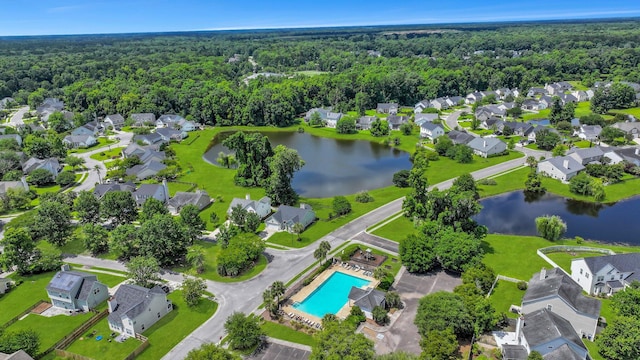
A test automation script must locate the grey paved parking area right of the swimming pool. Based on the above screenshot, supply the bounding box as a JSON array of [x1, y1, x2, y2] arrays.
[[374, 271, 462, 354]]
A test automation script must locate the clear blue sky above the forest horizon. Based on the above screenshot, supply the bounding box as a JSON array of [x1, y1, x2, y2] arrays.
[[0, 0, 640, 36]]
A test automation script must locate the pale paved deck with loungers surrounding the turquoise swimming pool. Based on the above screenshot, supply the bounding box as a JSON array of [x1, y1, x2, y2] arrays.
[[283, 264, 380, 323]]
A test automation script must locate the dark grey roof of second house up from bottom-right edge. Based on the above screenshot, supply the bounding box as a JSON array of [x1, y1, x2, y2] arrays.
[[522, 268, 601, 317]]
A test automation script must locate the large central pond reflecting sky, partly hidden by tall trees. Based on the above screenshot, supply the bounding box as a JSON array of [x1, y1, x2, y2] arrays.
[[204, 132, 411, 198]]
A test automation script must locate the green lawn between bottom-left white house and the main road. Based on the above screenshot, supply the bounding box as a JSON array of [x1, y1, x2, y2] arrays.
[[136, 290, 218, 360]]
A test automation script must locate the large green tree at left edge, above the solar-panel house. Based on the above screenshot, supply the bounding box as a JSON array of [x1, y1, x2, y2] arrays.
[[0, 227, 36, 275]]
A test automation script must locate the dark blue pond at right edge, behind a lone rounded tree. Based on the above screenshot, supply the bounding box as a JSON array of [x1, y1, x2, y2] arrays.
[[475, 191, 640, 245]]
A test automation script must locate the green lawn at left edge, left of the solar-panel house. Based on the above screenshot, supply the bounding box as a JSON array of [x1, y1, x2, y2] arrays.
[[0, 272, 55, 325]]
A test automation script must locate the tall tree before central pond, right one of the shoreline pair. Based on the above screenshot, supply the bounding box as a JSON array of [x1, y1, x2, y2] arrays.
[[265, 145, 304, 205]]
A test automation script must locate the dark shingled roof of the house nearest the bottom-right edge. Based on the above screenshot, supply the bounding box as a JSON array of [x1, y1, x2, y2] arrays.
[[522, 308, 587, 350]]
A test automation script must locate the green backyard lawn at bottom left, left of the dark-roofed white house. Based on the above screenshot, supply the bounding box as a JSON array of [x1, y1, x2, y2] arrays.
[[65, 318, 142, 359]]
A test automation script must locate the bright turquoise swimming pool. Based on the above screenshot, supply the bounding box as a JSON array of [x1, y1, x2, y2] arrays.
[[293, 271, 370, 318]]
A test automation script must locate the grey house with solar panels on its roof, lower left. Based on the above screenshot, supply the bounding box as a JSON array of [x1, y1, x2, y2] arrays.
[[46, 264, 109, 311]]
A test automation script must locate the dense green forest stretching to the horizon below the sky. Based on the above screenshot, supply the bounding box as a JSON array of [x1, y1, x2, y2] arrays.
[[0, 20, 640, 126]]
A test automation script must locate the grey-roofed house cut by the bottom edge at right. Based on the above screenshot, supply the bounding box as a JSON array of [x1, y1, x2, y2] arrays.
[[501, 308, 590, 360]]
